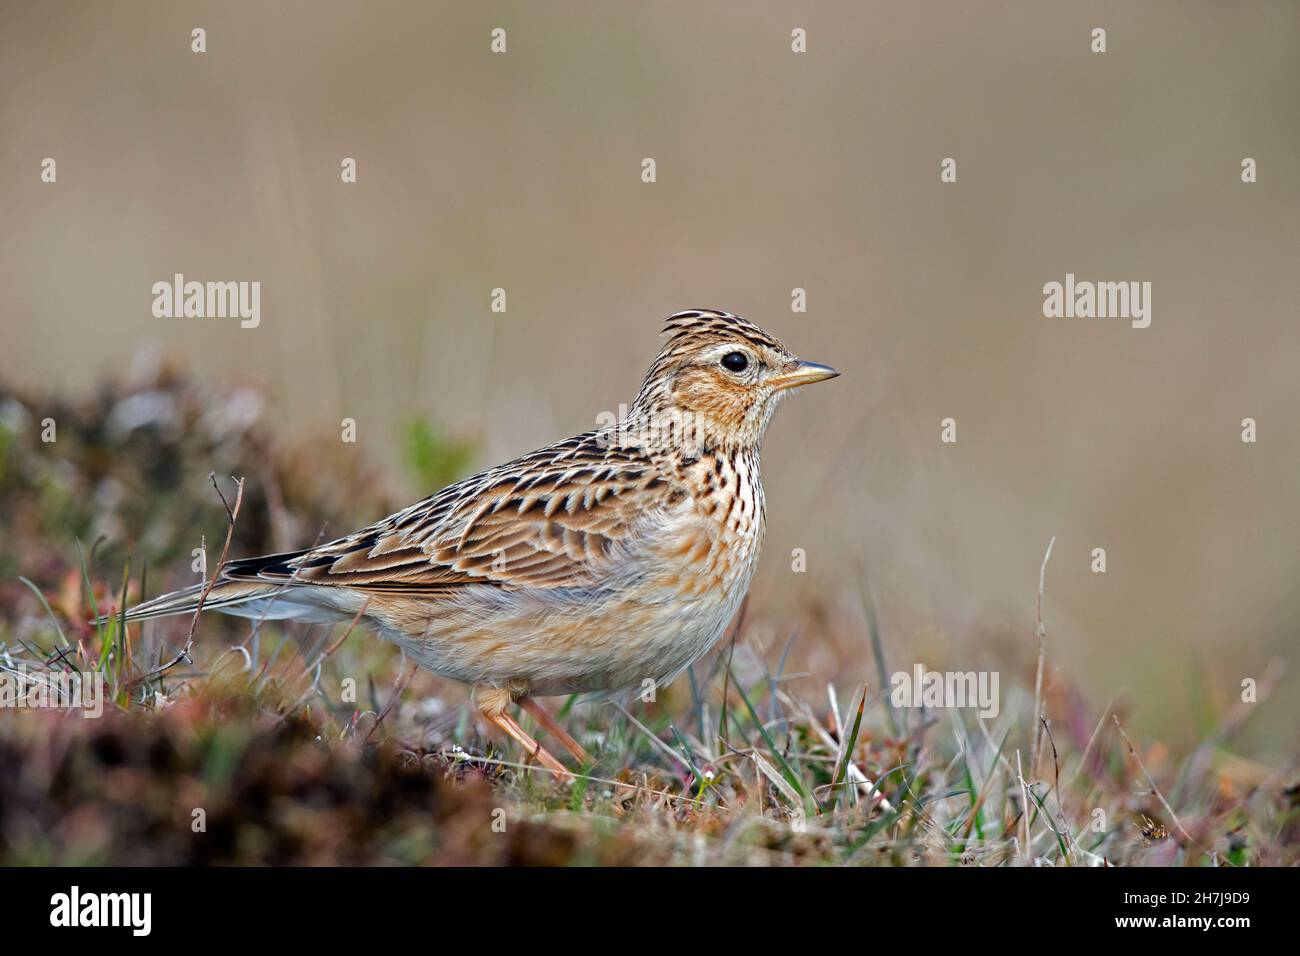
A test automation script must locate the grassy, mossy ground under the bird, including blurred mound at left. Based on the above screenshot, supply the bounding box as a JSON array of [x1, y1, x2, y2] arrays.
[[0, 369, 1300, 866]]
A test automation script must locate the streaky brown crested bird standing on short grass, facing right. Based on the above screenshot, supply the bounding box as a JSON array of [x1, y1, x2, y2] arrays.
[[111, 308, 839, 779]]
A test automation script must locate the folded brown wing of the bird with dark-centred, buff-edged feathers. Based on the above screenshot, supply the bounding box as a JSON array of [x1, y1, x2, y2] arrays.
[[219, 432, 684, 594]]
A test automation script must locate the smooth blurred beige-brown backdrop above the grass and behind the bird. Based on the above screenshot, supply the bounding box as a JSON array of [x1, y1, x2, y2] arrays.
[[0, 0, 1300, 756]]
